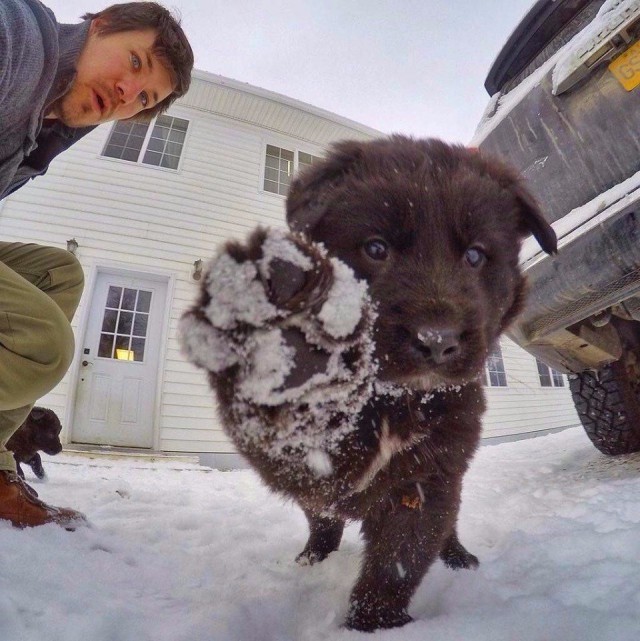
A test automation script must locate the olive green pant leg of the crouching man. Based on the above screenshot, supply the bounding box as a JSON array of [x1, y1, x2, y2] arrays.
[[0, 242, 84, 469]]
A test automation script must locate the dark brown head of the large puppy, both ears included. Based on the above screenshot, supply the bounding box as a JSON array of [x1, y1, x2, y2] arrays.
[[287, 137, 555, 388]]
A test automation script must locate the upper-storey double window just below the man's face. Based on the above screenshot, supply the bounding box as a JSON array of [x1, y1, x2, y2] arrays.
[[102, 115, 189, 169]]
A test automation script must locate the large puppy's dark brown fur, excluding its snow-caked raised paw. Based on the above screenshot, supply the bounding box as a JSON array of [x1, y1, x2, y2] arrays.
[[181, 136, 556, 630]]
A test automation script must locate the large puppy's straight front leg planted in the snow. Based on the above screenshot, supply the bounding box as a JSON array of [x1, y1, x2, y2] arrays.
[[346, 497, 455, 632]]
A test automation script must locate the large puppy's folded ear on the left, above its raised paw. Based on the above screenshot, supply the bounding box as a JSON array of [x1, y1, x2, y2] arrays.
[[287, 140, 363, 233]]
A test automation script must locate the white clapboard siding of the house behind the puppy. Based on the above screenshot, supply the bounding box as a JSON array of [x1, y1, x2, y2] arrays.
[[0, 72, 576, 456]]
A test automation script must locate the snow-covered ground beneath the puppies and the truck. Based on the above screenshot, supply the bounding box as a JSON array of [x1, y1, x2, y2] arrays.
[[0, 429, 640, 641]]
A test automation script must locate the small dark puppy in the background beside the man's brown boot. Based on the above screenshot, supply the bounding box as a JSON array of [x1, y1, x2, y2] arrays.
[[7, 407, 62, 479]]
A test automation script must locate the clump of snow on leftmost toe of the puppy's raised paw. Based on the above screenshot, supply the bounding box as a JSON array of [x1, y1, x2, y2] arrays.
[[178, 314, 238, 372]]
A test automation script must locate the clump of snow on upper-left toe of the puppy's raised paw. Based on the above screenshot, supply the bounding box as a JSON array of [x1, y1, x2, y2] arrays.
[[204, 254, 278, 329]]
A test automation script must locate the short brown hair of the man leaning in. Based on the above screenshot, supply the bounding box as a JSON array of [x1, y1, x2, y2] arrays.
[[82, 2, 193, 121]]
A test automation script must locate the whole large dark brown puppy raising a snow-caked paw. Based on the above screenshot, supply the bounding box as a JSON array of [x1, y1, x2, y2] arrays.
[[181, 136, 556, 631]]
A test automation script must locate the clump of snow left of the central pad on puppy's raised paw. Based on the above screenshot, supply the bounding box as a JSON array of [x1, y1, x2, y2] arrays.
[[238, 328, 295, 405]]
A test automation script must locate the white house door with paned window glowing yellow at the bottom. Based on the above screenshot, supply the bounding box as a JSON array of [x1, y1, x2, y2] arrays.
[[72, 273, 167, 448]]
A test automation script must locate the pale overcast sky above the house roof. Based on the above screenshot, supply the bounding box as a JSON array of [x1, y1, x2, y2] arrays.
[[44, 0, 534, 143]]
